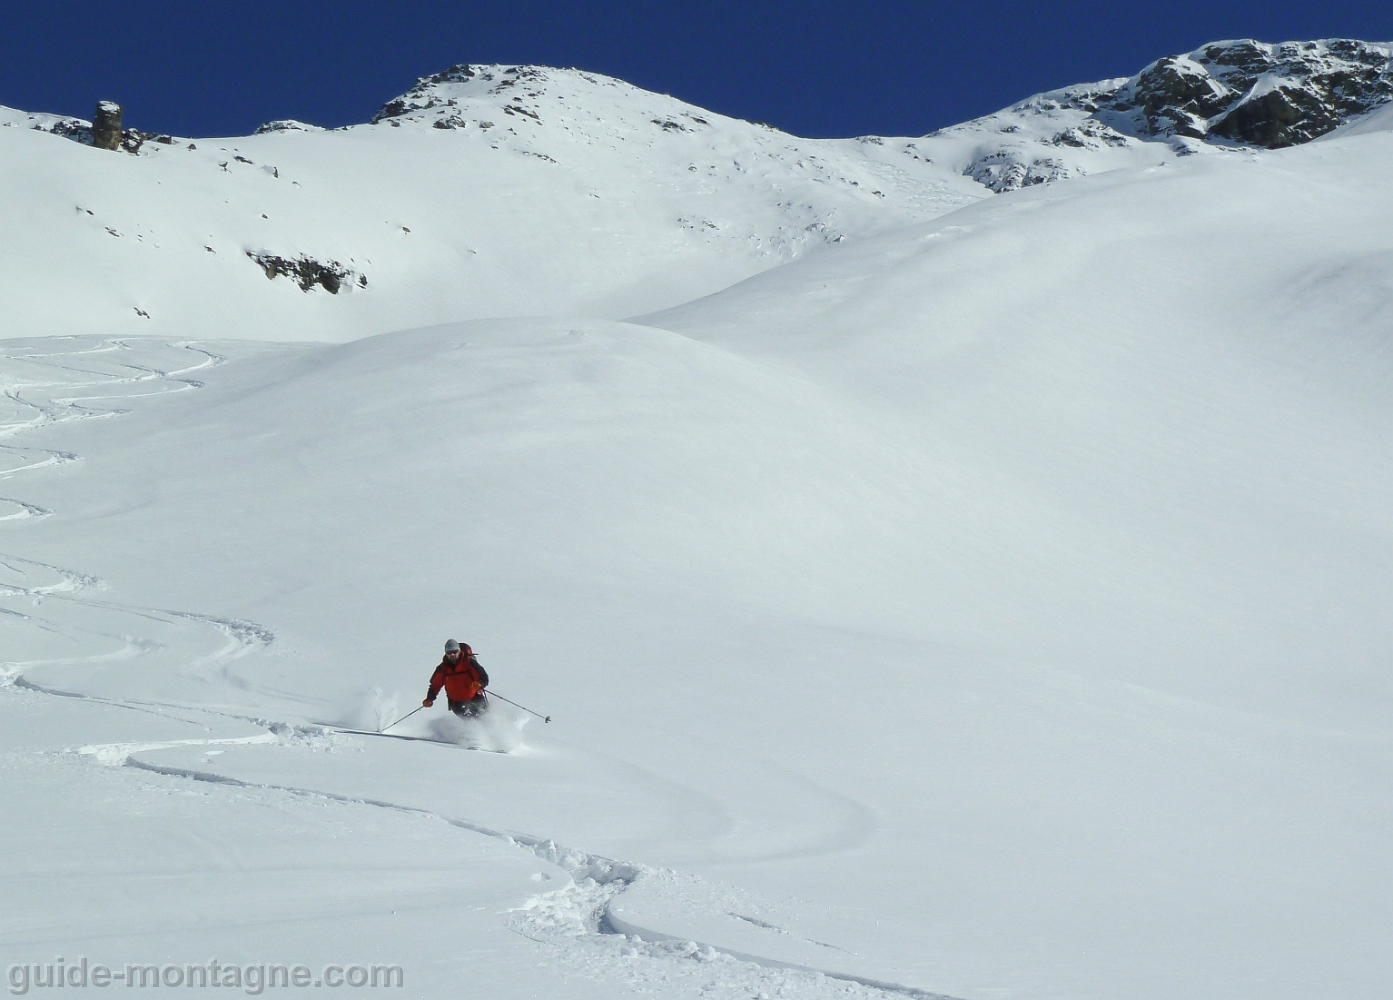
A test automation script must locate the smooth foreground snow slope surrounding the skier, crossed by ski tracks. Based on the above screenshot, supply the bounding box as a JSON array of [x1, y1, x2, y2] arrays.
[[0, 49, 1393, 1000]]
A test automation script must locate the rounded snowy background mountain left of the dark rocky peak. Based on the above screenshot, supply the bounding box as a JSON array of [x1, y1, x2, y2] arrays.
[[0, 67, 986, 341]]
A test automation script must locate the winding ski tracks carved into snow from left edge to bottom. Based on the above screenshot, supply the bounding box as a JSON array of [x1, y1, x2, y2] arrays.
[[0, 337, 954, 1000]]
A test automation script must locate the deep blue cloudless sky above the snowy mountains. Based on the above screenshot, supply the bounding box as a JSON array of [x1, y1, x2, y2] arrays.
[[0, 0, 1393, 136]]
